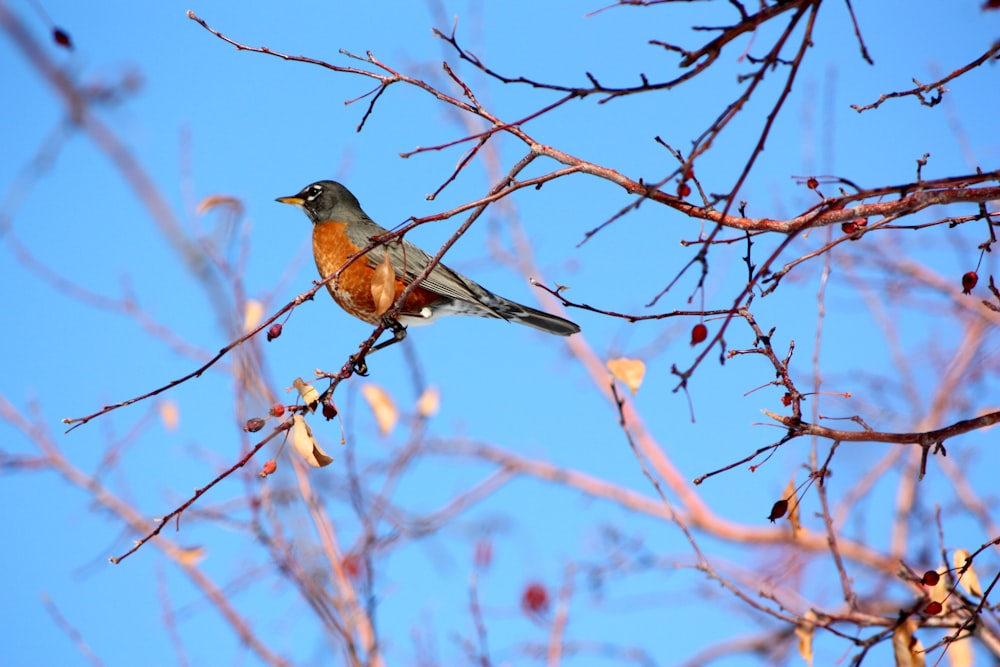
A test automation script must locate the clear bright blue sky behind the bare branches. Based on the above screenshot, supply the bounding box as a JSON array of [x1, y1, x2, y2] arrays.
[[0, 0, 1000, 665]]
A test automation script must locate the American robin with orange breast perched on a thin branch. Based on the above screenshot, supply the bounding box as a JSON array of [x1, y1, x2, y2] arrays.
[[276, 181, 580, 349]]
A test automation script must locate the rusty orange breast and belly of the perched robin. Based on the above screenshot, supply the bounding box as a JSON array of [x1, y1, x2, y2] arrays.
[[313, 222, 441, 324]]
